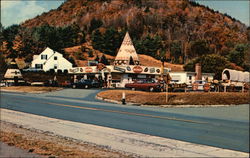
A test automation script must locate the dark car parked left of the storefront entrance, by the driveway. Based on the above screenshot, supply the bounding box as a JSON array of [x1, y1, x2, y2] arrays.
[[72, 79, 100, 89]]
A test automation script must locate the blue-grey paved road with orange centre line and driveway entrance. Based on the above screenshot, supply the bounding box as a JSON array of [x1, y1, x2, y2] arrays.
[[1, 89, 249, 152]]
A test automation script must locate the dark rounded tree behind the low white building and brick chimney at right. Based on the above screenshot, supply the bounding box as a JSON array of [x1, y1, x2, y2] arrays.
[[184, 54, 231, 79]]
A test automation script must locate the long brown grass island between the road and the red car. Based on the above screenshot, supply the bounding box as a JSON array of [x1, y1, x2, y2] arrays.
[[97, 90, 249, 105]]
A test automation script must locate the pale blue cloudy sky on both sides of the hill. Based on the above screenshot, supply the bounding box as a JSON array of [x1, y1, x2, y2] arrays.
[[1, 0, 250, 27]]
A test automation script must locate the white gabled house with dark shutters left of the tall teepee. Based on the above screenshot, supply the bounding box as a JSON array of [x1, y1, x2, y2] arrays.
[[31, 47, 72, 72]]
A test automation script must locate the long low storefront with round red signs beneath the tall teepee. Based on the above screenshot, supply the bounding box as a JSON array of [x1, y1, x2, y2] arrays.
[[69, 65, 170, 87]]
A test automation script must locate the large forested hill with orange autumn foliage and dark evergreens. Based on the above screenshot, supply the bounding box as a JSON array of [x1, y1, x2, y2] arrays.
[[0, 0, 250, 76]]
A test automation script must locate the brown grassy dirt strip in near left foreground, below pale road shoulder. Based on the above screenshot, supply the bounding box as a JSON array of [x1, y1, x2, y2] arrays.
[[0, 121, 129, 157]]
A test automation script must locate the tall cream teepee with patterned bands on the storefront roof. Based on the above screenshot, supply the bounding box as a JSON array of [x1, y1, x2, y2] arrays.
[[114, 32, 140, 65]]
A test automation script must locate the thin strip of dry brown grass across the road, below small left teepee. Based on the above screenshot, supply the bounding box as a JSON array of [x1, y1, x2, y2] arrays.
[[1, 86, 62, 93]]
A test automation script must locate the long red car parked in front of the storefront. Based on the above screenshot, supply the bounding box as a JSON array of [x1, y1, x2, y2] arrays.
[[125, 79, 161, 92]]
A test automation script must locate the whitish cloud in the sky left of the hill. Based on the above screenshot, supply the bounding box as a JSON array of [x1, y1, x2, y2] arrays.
[[1, 0, 48, 27]]
